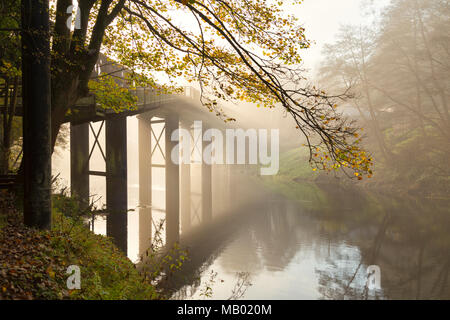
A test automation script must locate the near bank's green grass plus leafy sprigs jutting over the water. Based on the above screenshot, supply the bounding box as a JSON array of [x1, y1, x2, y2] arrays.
[[52, 188, 188, 299]]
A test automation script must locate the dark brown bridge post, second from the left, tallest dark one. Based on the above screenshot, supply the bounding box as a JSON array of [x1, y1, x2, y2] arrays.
[[106, 117, 128, 254]]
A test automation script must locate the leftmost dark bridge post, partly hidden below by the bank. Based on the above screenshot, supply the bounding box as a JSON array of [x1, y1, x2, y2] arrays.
[[70, 123, 89, 206]]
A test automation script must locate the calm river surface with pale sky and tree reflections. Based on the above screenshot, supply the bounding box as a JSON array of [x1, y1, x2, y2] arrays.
[[166, 185, 450, 299]]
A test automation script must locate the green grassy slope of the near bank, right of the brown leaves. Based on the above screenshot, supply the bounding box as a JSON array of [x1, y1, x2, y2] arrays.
[[51, 210, 157, 300]]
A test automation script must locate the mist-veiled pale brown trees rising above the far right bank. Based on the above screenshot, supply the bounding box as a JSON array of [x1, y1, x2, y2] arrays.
[[323, 0, 450, 195]]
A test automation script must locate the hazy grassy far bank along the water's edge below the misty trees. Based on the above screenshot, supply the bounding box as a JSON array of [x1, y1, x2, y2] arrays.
[[265, 129, 450, 200]]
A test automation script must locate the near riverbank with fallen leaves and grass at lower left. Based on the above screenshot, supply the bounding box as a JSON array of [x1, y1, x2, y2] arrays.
[[0, 193, 159, 300]]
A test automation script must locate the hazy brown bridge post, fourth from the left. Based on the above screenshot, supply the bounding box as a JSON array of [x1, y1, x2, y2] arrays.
[[165, 114, 180, 247]]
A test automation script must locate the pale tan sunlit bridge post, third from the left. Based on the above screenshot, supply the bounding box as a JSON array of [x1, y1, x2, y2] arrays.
[[138, 118, 152, 256]]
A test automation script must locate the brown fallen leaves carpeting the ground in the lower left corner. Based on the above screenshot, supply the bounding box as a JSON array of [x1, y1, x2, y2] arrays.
[[0, 195, 69, 300]]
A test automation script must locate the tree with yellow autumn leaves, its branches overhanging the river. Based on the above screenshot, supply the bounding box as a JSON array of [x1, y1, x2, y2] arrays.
[[44, 0, 371, 178]]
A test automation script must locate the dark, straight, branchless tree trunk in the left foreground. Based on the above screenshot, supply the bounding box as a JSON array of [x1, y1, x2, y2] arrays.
[[21, 0, 51, 229]]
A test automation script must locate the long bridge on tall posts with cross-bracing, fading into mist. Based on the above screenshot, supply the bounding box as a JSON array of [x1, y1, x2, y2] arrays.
[[67, 53, 255, 254]]
